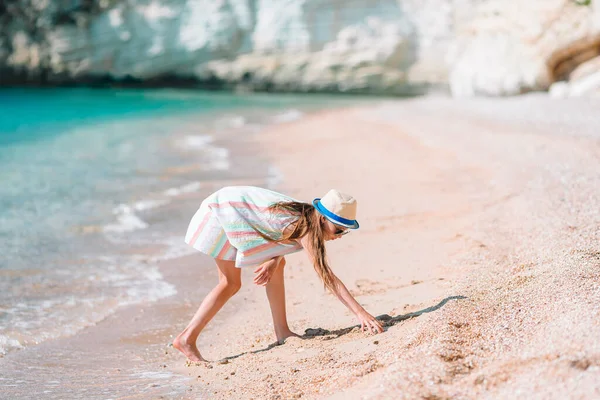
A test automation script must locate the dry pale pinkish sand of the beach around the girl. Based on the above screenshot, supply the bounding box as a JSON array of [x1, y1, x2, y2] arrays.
[[169, 95, 600, 399]]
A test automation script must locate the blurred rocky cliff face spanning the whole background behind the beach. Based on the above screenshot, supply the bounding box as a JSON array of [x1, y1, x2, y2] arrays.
[[0, 0, 600, 96]]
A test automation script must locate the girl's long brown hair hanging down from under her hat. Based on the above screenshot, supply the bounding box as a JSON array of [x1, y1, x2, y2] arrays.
[[259, 201, 335, 292]]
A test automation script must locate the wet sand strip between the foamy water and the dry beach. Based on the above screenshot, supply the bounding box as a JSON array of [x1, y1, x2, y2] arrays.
[[0, 98, 370, 398]]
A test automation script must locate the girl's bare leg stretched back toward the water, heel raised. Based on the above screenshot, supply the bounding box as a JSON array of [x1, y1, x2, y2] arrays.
[[173, 259, 242, 361]]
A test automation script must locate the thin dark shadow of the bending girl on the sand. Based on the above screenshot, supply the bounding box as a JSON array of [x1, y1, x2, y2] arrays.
[[209, 296, 466, 364]]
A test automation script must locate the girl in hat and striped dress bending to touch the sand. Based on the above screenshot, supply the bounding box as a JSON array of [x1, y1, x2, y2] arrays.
[[173, 186, 383, 361]]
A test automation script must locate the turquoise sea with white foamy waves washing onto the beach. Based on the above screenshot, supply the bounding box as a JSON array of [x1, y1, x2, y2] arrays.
[[0, 89, 350, 354]]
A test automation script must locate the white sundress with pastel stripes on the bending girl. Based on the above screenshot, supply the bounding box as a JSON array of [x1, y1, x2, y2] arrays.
[[185, 186, 302, 268]]
